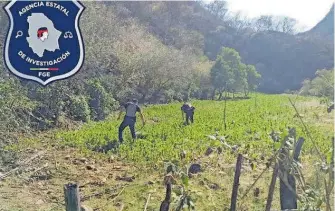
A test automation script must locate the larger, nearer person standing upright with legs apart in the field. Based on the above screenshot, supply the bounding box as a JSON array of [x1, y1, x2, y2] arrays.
[[118, 99, 145, 143]]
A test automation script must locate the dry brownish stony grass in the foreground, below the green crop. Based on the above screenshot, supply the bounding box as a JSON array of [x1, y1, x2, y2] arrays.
[[0, 138, 278, 211]]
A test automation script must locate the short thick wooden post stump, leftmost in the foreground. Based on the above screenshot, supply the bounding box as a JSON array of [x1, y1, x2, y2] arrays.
[[64, 183, 81, 211]]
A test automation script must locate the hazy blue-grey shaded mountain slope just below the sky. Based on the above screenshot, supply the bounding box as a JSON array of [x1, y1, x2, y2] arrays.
[[117, 2, 334, 93]]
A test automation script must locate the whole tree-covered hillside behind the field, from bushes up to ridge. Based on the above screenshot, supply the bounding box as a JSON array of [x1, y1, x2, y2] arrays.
[[0, 1, 333, 135]]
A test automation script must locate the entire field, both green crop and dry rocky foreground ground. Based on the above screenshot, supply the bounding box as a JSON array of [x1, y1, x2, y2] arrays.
[[0, 94, 333, 211]]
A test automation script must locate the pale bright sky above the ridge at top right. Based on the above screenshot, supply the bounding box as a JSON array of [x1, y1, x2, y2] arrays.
[[208, 0, 334, 30]]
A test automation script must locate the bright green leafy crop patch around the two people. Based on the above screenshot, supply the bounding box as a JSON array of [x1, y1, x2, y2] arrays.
[[57, 95, 332, 165]]
